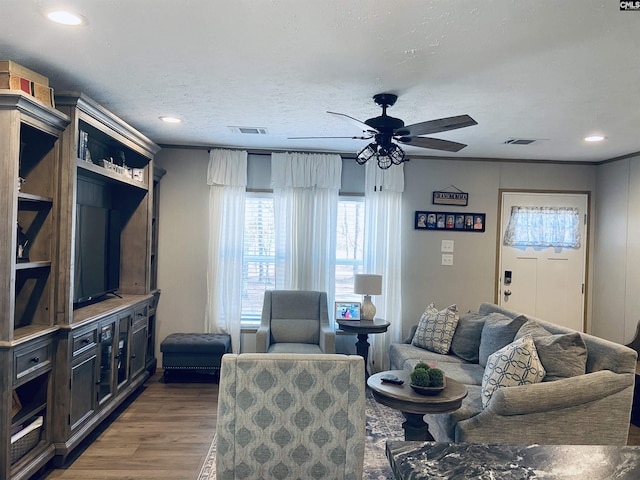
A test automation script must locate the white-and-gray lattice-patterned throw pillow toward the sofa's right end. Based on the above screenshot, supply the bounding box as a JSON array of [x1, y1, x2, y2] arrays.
[[482, 335, 546, 408]]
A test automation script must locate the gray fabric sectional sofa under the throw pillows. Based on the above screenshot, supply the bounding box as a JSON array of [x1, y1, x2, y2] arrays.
[[389, 303, 637, 445]]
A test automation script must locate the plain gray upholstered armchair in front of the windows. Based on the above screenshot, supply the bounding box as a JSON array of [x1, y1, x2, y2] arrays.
[[256, 290, 336, 353]]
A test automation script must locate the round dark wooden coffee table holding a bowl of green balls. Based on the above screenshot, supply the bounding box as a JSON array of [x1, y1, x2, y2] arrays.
[[367, 370, 467, 441]]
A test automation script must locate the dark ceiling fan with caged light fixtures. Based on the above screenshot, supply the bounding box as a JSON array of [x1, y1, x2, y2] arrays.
[[291, 93, 478, 169]]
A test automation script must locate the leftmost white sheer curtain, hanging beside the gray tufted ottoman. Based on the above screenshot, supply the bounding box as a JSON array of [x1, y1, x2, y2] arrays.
[[204, 149, 247, 353]]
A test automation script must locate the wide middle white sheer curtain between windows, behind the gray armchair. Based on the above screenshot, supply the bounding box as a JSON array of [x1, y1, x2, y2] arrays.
[[271, 153, 342, 322]]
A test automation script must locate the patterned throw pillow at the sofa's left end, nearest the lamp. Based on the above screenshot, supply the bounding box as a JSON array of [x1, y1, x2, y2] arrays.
[[411, 303, 459, 355]]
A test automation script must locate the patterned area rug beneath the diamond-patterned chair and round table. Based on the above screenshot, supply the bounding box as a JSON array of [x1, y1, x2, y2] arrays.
[[198, 390, 404, 480]]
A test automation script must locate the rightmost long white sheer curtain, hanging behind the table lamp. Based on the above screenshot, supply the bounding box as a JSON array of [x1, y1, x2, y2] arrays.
[[364, 162, 404, 372]]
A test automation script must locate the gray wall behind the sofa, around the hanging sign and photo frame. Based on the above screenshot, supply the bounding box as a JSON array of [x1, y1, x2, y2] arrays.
[[402, 159, 595, 335]]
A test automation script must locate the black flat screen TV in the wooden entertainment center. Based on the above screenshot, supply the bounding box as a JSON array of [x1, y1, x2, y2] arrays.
[[73, 204, 120, 305]]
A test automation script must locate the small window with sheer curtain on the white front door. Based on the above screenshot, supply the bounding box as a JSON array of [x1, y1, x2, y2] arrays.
[[504, 206, 580, 248]]
